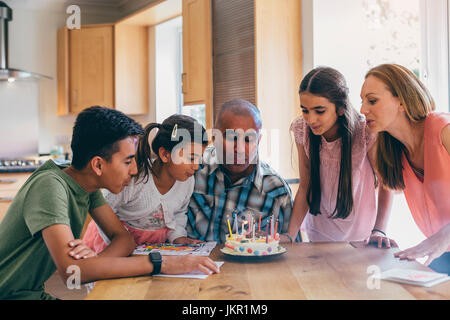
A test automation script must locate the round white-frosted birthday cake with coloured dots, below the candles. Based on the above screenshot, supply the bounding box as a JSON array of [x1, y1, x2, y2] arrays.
[[224, 233, 284, 256]]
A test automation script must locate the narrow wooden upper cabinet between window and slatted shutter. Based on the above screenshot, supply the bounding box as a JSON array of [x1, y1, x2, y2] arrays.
[[182, 0, 213, 128]]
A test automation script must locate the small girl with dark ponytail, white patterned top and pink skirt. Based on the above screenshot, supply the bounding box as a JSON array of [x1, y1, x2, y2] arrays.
[[83, 115, 208, 253]]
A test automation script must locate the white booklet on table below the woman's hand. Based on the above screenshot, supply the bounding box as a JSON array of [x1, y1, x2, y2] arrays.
[[380, 269, 450, 287]]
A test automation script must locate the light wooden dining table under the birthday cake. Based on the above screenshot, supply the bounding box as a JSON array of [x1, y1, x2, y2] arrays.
[[86, 242, 450, 300]]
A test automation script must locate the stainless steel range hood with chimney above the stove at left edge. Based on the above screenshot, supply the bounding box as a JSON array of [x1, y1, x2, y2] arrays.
[[0, 1, 51, 82]]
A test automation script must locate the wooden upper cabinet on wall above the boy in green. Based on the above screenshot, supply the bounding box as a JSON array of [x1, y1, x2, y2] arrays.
[[58, 24, 149, 115]]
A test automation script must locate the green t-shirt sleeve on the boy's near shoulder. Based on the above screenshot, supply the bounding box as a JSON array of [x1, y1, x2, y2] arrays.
[[23, 175, 70, 236]]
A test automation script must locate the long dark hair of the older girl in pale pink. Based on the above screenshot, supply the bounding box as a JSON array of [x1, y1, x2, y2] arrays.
[[299, 67, 361, 219]]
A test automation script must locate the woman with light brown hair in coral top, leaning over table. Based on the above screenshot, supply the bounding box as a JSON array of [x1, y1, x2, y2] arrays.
[[361, 64, 450, 273]]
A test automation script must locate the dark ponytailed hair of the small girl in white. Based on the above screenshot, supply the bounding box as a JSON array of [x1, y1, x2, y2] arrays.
[[136, 114, 208, 183]]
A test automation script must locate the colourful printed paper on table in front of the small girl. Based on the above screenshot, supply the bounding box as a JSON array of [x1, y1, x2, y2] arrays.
[[133, 241, 217, 257]]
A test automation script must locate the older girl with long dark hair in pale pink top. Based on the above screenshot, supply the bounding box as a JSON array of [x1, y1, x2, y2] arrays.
[[288, 67, 396, 247]]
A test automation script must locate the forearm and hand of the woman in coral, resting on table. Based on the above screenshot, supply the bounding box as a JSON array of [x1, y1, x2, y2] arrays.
[[394, 224, 450, 266]]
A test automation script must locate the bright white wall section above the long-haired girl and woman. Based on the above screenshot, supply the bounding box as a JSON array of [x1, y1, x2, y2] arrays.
[[312, 0, 420, 110]]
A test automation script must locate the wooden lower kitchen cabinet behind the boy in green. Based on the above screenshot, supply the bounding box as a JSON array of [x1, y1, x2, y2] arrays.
[[0, 172, 31, 222]]
